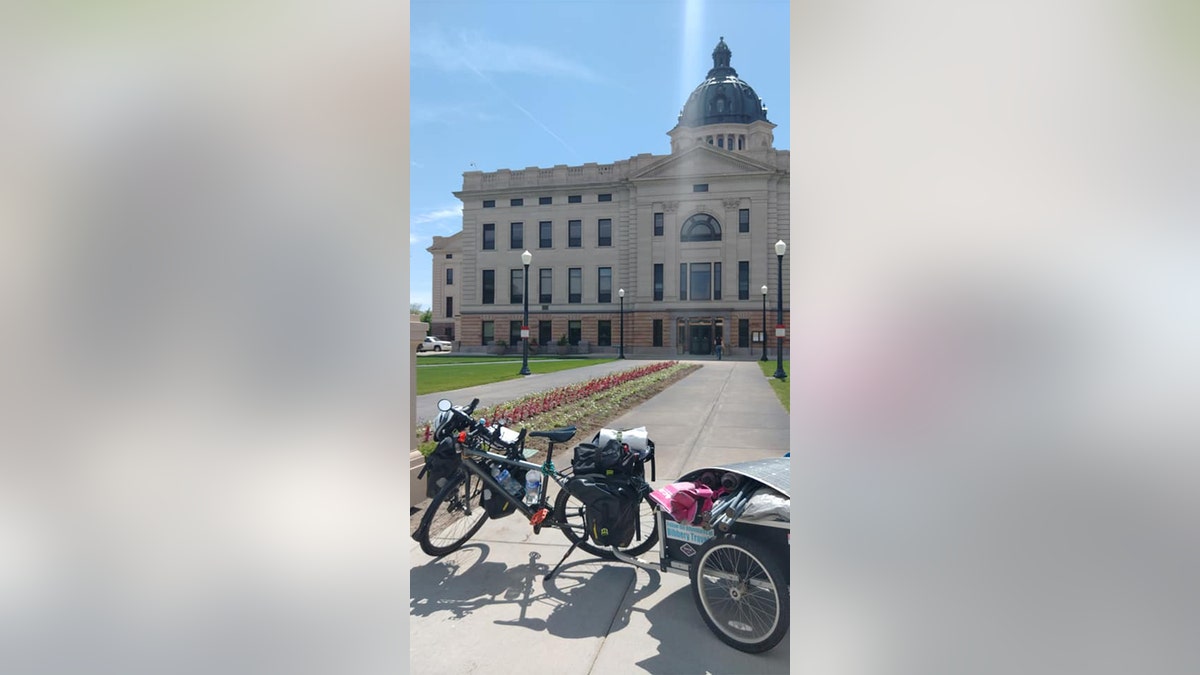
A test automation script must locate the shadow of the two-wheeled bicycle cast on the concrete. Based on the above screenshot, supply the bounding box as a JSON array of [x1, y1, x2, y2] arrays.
[[409, 543, 660, 639]]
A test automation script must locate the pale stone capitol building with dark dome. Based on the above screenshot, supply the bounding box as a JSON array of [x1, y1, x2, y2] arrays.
[[427, 38, 792, 359]]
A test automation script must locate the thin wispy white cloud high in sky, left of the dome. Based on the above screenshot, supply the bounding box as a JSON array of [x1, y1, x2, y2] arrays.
[[412, 30, 601, 82]]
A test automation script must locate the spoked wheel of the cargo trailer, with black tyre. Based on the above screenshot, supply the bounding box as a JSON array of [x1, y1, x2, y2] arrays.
[[690, 534, 790, 653]]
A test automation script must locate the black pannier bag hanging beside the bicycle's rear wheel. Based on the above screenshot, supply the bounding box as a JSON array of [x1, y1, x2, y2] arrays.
[[566, 474, 650, 548]]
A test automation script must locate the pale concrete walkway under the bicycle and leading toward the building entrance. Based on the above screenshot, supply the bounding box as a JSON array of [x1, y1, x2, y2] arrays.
[[409, 360, 790, 675]]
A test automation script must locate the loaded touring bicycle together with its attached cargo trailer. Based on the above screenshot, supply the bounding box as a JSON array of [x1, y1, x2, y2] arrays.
[[413, 399, 790, 652]]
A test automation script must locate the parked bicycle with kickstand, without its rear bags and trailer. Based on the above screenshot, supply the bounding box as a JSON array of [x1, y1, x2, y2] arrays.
[[413, 399, 659, 579]]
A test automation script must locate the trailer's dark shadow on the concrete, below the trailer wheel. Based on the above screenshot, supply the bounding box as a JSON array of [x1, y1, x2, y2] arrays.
[[637, 586, 791, 675]]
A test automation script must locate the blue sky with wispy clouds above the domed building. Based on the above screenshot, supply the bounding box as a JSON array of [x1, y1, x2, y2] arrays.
[[409, 0, 791, 306]]
